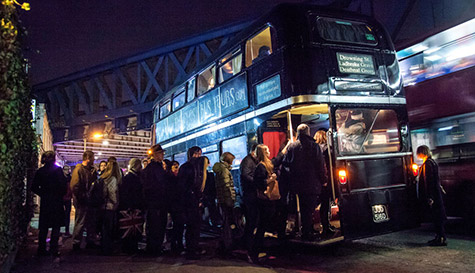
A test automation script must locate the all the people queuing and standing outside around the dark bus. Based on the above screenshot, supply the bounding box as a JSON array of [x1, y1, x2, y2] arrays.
[[32, 126, 447, 263]]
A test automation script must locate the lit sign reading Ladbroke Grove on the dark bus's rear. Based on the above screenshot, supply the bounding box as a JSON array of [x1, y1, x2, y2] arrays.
[[336, 52, 376, 75]]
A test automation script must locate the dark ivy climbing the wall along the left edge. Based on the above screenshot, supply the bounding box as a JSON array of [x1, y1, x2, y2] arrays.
[[0, 0, 37, 265]]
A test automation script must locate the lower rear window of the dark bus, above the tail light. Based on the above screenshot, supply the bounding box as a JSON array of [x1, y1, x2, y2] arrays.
[[335, 108, 401, 155]]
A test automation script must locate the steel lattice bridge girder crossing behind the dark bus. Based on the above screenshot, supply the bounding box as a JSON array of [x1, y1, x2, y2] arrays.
[[34, 22, 249, 141]]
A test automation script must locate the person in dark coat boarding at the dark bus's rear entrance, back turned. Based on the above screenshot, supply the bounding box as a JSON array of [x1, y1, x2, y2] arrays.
[[283, 124, 325, 240]]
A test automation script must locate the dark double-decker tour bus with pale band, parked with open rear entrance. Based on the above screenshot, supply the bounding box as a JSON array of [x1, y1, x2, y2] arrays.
[[153, 4, 418, 243]]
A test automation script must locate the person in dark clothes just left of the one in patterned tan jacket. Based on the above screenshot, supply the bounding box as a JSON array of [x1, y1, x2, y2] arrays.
[[178, 154, 209, 260]]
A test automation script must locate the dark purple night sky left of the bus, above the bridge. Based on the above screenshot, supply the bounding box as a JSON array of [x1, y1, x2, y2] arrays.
[[21, 0, 302, 84]]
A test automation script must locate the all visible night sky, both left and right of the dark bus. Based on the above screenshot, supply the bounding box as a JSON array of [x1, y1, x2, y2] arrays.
[[20, 0, 475, 85]]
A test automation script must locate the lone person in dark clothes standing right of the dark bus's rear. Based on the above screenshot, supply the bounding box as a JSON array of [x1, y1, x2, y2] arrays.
[[416, 145, 447, 246]]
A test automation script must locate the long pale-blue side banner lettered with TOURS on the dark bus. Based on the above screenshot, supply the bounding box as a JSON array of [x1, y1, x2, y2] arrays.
[[155, 74, 249, 143]]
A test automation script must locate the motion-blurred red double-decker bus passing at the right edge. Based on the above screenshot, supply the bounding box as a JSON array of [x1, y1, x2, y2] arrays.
[[397, 19, 475, 223]]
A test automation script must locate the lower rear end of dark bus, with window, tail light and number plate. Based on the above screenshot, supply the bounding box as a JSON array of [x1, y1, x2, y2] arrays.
[[331, 106, 417, 239]]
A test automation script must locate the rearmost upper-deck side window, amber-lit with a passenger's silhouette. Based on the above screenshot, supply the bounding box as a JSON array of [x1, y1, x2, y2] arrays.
[[246, 27, 272, 67]]
